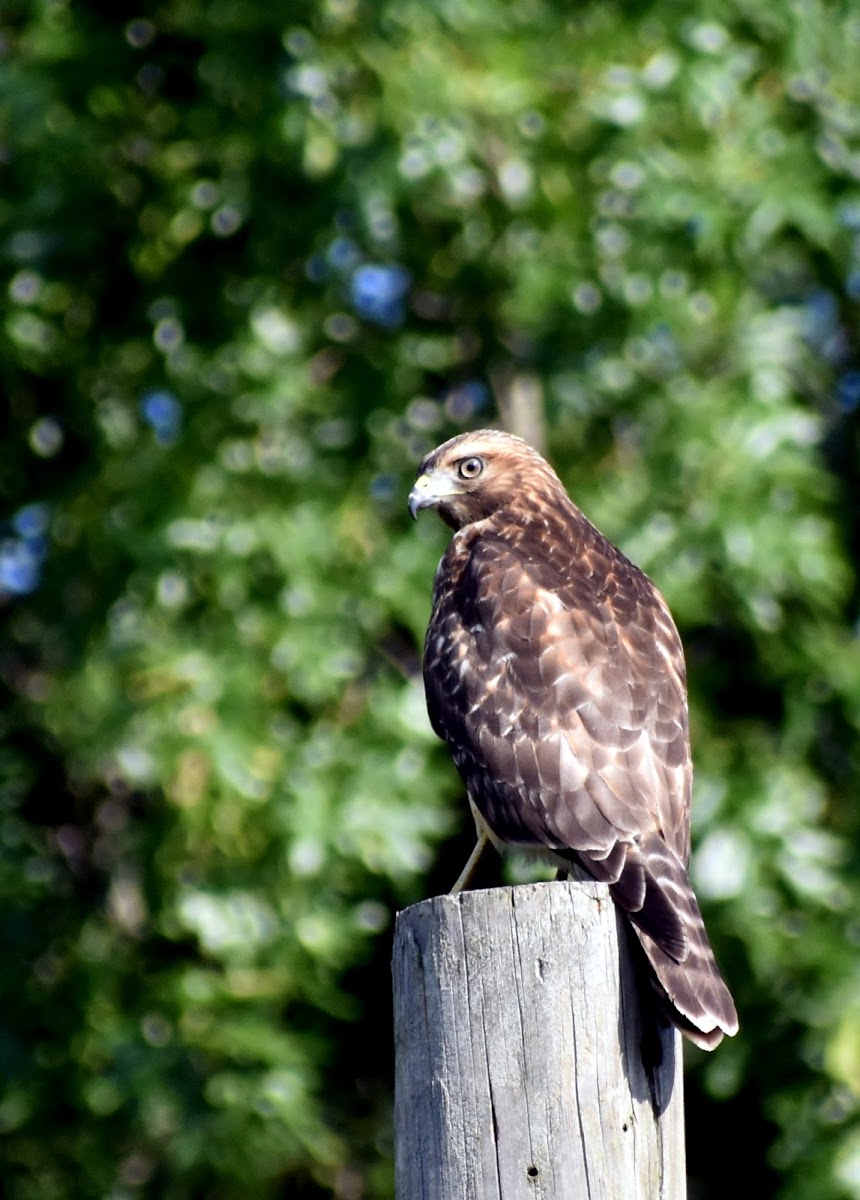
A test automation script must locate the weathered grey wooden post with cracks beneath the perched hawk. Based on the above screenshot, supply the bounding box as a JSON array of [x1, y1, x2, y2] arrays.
[[393, 882, 686, 1200]]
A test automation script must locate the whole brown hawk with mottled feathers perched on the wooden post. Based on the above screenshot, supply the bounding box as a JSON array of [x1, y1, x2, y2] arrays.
[[409, 430, 738, 1050]]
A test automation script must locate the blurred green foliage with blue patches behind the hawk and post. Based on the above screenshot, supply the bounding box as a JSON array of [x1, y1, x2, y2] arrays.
[[0, 0, 860, 1200]]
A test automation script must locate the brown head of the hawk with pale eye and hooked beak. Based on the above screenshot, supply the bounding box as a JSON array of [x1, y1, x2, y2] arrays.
[[409, 430, 567, 529]]
